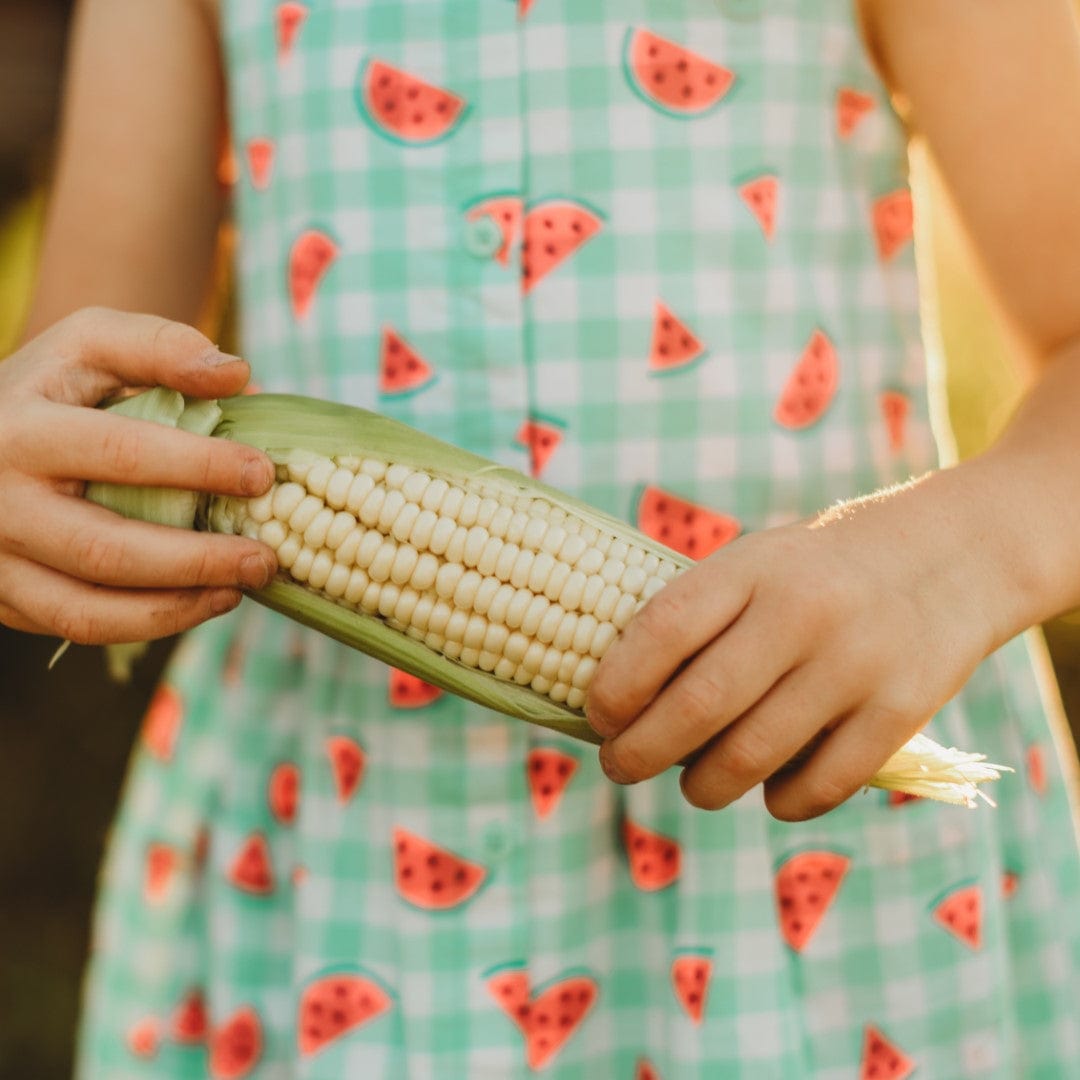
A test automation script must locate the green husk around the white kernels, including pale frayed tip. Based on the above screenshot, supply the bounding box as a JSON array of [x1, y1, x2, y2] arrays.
[[86, 388, 1011, 806]]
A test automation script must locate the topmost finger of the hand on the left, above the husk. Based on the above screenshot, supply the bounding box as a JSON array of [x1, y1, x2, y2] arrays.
[[40, 308, 251, 405]]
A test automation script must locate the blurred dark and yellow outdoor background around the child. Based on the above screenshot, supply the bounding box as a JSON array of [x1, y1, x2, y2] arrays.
[[0, 0, 1080, 1080]]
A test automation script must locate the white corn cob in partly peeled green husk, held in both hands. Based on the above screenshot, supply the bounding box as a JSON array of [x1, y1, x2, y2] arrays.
[[87, 389, 998, 805]]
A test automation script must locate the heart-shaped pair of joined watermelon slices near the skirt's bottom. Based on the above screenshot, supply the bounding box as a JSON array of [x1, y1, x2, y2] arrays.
[[487, 970, 598, 1069]]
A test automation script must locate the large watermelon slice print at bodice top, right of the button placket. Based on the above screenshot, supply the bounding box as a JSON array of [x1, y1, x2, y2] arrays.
[[623, 28, 734, 117]]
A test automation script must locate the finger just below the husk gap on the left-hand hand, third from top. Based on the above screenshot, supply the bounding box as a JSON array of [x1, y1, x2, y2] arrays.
[[8, 494, 276, 589]]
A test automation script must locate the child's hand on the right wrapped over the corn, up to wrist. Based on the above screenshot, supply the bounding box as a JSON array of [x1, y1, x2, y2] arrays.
[[588, 470, 1021, 821]]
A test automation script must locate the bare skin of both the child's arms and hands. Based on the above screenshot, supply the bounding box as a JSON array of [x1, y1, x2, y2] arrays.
[[0, 0, 1080, 820]]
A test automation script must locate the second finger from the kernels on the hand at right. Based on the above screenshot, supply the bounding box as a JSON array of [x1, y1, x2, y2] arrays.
[[600, 618, 797, 783]]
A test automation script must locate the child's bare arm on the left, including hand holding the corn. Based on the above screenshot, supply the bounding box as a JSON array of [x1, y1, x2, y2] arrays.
[[0, 0, 273, 642]]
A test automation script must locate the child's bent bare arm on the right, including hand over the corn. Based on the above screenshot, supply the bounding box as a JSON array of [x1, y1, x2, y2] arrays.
[[590, 0, 1080, 820]]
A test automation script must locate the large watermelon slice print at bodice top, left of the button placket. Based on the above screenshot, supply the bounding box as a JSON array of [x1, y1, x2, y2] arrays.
[[357, 59, 468, 146]]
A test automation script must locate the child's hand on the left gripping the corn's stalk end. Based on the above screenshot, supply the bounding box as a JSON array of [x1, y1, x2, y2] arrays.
[[0, 308, 276, 644]]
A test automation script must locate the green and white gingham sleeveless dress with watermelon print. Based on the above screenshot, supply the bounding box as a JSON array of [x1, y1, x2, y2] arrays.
[[79, 0, 1080, 1080]]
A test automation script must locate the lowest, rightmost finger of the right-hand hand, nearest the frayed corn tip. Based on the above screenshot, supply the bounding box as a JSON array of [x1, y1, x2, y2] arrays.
[[765, 706, 924, 821]]
